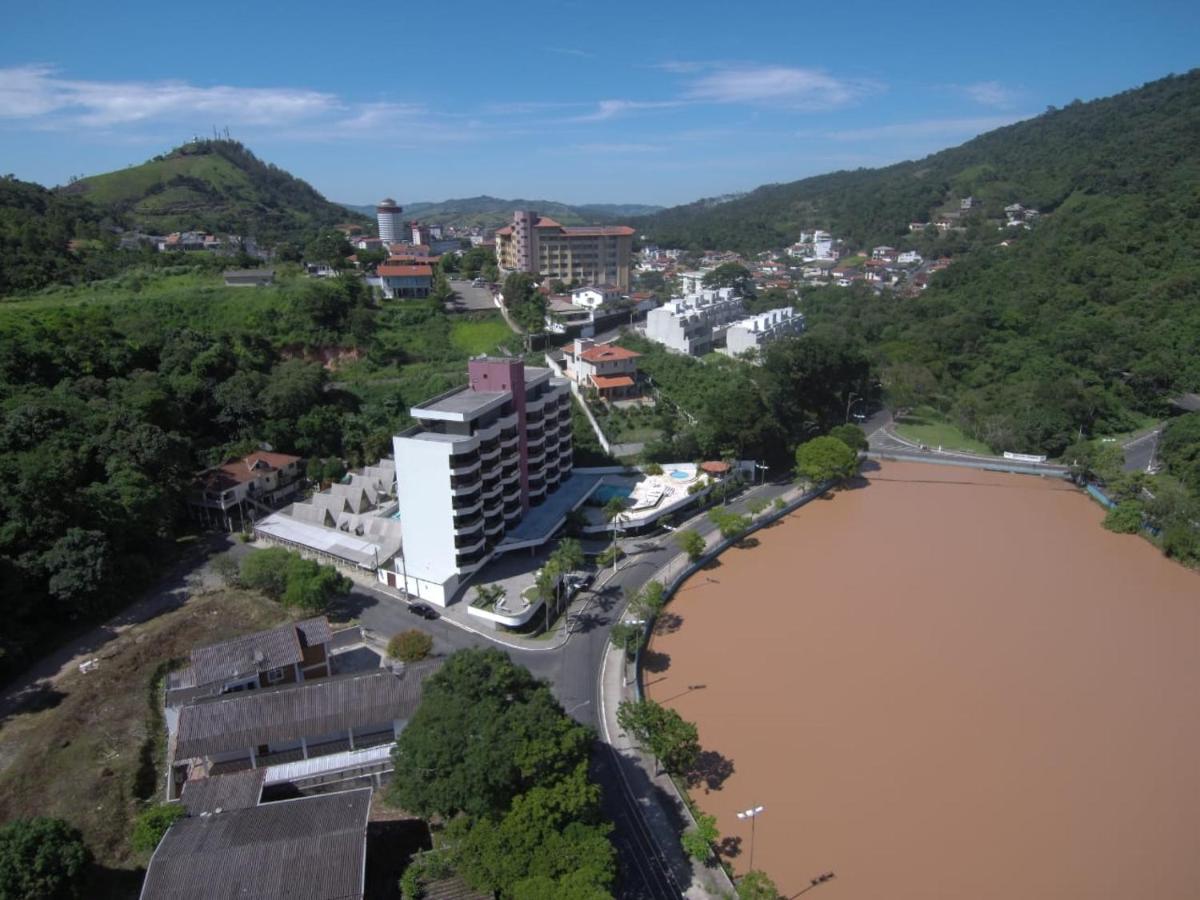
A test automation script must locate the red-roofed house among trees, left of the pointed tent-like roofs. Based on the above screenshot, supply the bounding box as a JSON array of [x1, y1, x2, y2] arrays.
[[187, 450, 304, 528]]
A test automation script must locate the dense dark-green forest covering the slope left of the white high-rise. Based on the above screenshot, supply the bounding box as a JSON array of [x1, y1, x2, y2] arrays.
[[0, 268, 512, 679]]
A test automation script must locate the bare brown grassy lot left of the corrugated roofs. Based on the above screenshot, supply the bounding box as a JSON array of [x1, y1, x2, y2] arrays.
[[0, 590, 289, 875]]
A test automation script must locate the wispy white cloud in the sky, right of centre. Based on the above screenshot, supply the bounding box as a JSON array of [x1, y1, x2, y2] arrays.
[[673, 64, 882, 110]]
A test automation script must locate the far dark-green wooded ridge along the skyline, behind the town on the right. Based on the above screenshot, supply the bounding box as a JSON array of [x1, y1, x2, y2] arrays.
[[648, 70, 1200, 252]]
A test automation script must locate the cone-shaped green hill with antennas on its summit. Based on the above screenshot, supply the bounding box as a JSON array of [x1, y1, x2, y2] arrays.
[[61, 140, 360, 242]]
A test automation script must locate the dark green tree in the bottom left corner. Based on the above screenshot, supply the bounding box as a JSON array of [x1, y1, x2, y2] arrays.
[[0, 818, 91, 900]]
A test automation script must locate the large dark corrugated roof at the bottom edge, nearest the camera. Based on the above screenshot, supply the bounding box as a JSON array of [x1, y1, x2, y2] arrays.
[[142, 787, 371, 900]]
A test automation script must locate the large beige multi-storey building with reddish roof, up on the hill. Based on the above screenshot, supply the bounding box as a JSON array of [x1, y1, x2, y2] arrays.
[[496, 210, 634, 290]]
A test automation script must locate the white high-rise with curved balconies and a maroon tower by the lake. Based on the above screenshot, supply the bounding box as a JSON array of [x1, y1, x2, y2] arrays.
[[393, 358, 572, 606]]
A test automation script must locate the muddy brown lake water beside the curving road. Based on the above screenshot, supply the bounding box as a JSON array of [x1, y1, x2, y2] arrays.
[[646, 463, 1200, 900]]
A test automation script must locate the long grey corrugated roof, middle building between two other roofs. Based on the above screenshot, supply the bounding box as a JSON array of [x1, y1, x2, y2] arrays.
[[175, 660, 442, 760]]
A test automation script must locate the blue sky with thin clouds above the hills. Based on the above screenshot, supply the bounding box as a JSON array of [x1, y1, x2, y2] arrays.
[[0, 0, 1200, 204]]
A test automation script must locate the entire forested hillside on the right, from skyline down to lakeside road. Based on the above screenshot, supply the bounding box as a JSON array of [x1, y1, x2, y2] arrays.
[[647, 71, 1200, 455]]
